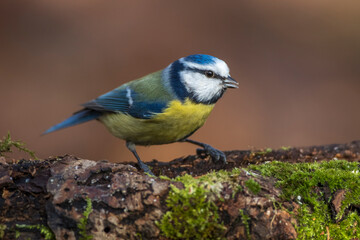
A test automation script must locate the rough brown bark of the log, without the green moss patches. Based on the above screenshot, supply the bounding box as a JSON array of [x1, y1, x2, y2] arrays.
[[0, 141, 360, 239]]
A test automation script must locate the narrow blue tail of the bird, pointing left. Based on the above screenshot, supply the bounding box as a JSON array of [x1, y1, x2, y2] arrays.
[[43, 109, 101, 134]]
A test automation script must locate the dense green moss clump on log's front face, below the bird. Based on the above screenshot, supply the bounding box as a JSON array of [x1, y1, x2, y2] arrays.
[[158, 181, 224, 239]]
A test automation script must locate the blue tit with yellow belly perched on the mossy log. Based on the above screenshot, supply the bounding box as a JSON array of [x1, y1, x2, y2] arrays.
[[44, 54, 238, 175]]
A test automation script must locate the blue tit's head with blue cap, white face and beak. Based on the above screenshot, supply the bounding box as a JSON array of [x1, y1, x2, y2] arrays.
[[164, 54, 238, 104]]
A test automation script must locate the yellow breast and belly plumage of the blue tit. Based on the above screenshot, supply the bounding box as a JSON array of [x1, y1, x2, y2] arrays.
[[100, 99, 214, 145]]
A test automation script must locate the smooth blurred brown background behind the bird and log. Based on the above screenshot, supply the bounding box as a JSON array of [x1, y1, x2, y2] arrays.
[[0, 0, 360, 162]]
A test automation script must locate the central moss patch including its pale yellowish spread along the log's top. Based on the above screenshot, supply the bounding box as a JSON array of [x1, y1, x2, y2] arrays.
[[157, 168, 248, 239]]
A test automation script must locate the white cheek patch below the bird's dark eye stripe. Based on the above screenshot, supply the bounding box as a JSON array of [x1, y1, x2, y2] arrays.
[[181, 71, 223, 102]]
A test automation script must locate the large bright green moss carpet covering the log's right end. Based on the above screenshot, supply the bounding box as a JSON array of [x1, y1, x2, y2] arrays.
[[249, 160, 360, 239]]
